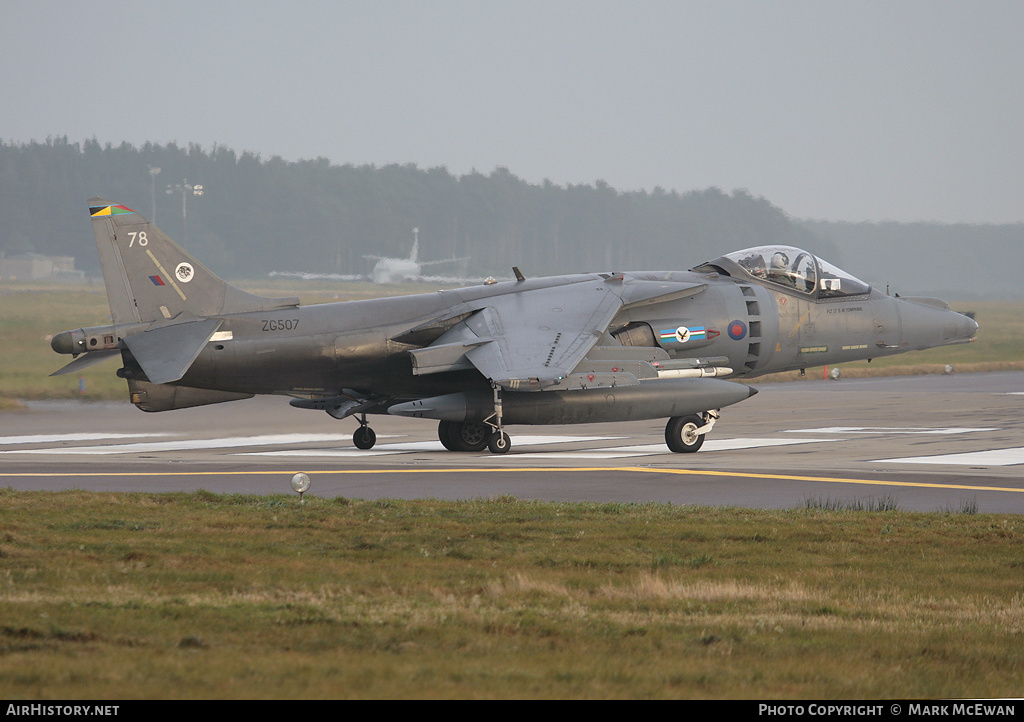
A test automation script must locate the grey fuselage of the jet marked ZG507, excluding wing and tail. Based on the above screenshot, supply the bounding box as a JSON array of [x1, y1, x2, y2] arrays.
[[127, 266, 977, 399]]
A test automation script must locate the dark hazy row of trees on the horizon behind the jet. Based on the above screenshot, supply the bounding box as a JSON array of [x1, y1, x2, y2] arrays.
[[0, 137, 827, 278]]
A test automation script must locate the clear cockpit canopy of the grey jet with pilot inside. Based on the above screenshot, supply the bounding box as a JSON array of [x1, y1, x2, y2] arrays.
[[698, 246, 871, 298]]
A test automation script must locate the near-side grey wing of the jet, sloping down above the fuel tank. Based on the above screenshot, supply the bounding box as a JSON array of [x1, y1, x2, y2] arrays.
[[410, 277, 705, 391]]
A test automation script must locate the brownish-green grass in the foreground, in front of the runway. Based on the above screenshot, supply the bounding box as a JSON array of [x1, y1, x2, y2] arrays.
[[0, 490, 1024, 699]]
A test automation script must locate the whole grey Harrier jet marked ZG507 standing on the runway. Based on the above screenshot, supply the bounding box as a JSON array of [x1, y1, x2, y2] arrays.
[[51, 198, 978, 453]]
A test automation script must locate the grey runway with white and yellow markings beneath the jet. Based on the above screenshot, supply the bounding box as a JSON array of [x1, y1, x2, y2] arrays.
[[0, 372, 1024, 513]]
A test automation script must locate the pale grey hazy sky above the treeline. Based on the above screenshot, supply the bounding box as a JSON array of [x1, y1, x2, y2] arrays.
[[0, 0, 1024, 222]]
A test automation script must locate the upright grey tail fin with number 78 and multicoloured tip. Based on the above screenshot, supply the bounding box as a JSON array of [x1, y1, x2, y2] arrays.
[[89, 198, 299, 325]]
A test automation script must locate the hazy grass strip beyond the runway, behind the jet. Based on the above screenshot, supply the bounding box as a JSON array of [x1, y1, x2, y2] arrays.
[[0, 280, 1024, 409]]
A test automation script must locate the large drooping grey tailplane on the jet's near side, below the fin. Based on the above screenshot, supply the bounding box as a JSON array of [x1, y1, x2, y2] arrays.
[[124, 318, 224, 384]]
